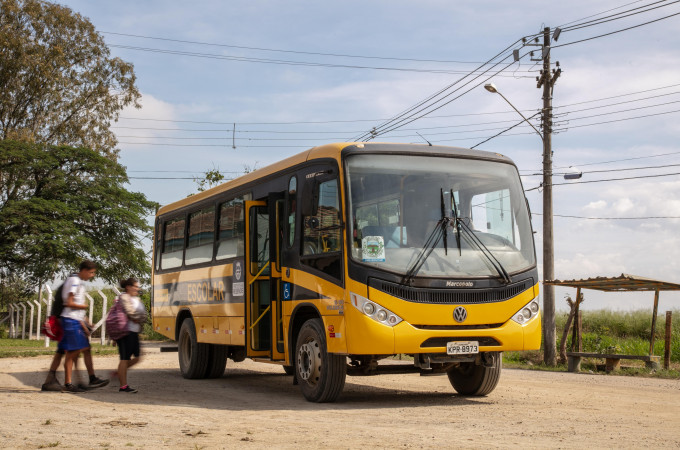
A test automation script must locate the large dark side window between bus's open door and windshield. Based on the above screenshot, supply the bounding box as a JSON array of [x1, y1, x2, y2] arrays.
[[302, 179, 342, 279]]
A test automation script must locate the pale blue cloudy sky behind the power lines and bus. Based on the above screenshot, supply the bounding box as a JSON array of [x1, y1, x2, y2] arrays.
[[58, 0, 680, 311]]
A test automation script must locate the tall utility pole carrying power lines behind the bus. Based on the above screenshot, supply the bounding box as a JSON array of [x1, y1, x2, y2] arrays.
[[536, 27, 561, 366]]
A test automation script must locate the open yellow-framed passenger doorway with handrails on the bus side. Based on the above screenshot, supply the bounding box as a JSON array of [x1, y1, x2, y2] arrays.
[[245, 201, 276, 357]]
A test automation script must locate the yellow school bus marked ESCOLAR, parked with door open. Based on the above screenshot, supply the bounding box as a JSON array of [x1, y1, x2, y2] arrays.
[[152, 143, 541, 402]]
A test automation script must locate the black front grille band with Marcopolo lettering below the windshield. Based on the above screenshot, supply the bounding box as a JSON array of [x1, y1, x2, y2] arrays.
[[369, 278, 533, 305]]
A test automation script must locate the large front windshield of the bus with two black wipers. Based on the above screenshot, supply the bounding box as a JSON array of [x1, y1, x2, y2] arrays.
[[346, 154, 535, 278]]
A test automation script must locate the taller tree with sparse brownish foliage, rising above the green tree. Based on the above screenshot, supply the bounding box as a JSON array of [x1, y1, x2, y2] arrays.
[[0, 0, 141, 158]]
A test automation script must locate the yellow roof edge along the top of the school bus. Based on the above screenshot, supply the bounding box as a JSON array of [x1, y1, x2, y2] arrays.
[[156, 142, 512, 216]]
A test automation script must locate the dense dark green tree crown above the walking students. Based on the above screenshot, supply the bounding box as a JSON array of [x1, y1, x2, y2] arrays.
[[0, 140, 157, 300]]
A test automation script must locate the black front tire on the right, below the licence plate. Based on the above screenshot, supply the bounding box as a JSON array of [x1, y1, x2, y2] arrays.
[[447, 352, 503, 396]]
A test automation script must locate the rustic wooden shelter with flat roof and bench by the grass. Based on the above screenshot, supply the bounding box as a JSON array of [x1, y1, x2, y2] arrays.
[[544, 274, 680, 371]]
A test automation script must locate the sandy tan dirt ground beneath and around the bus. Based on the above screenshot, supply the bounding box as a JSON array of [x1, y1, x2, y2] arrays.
[[0, 342, 680, 449]]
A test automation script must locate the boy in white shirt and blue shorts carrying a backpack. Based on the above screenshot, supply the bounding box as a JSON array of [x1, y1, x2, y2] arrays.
[[42, 260, 109, 392]]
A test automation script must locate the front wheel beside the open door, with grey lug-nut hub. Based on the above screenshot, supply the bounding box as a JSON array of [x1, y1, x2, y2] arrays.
[[295, 319, 347, 403]]
